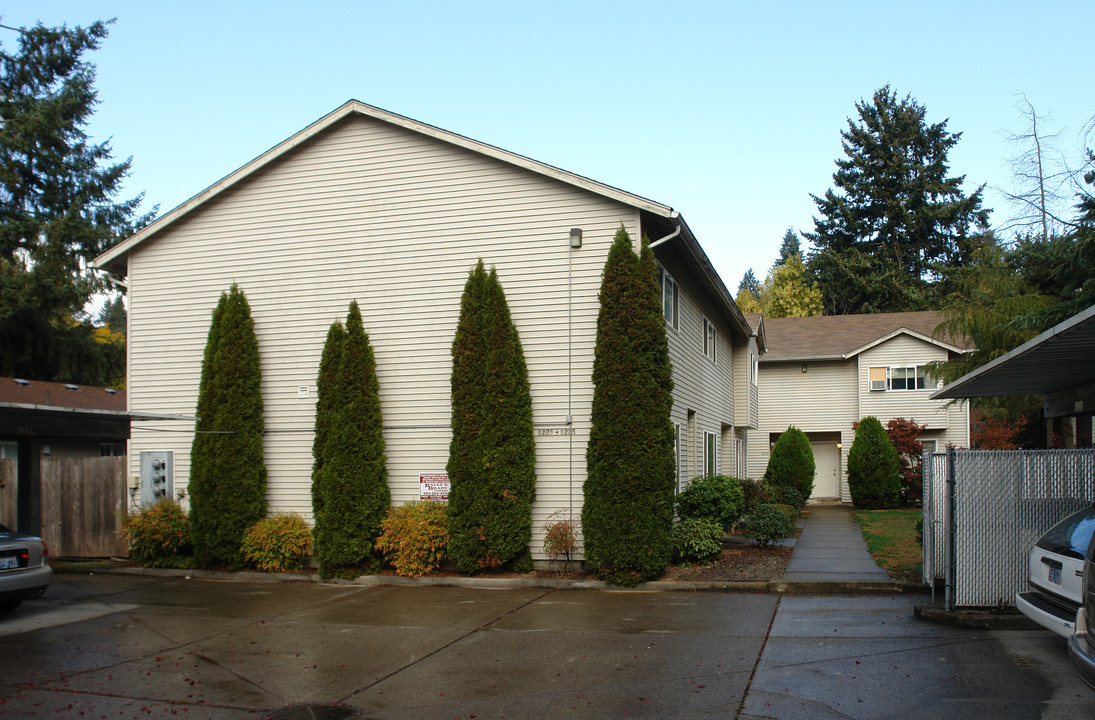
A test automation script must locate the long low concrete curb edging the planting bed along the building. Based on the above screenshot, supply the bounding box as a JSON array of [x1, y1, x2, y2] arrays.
[[55, 567, 929, 595]]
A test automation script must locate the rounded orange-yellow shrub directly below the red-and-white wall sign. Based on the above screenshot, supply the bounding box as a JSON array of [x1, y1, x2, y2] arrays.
[[377, 500, 449, 578]]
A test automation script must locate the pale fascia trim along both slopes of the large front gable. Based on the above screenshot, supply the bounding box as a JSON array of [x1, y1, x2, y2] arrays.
[[91, 100, 677, 269]]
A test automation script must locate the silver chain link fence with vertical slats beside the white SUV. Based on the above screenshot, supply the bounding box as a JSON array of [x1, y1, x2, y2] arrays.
[[923, 449, 1095, 609]]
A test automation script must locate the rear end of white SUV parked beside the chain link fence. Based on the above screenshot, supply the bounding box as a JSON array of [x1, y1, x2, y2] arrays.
[[1015, 504, 1095, 638]]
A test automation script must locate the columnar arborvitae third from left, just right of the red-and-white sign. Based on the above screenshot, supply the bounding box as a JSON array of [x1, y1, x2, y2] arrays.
[[448, 259, 535, 572]]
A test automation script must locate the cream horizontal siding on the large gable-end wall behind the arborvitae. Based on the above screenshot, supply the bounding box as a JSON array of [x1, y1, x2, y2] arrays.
[[129, 117, 638, 554]]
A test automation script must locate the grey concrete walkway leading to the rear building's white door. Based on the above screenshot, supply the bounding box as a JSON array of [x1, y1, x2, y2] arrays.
[[780, 502, 889, 583]]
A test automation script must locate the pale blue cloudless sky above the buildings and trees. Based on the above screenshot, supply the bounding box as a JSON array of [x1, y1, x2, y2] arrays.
[[0, 0, 1095, 293]]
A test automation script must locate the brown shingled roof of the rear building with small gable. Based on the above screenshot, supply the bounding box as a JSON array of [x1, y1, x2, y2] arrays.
[[761, 311, 972, 362]]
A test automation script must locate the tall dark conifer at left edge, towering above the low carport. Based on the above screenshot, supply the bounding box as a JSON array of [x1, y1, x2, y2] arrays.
[[0, 22, 151, 385]]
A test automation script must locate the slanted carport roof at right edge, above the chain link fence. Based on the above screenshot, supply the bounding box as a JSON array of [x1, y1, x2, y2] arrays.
[[932, 305, 1095, 399]]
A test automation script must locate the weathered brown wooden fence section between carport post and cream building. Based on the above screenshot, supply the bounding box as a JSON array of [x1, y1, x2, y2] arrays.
[[42, 457, 127, 557]]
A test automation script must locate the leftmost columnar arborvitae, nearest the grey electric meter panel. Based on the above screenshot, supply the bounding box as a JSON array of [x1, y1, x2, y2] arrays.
[[187, 284, 266, 567]]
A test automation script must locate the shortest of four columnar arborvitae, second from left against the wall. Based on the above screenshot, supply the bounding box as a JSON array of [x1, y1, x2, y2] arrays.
[[312, 301, 391, 578]]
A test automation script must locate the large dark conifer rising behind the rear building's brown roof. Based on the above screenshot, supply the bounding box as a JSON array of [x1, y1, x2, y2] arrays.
[[804, 85, 988, 314]]
